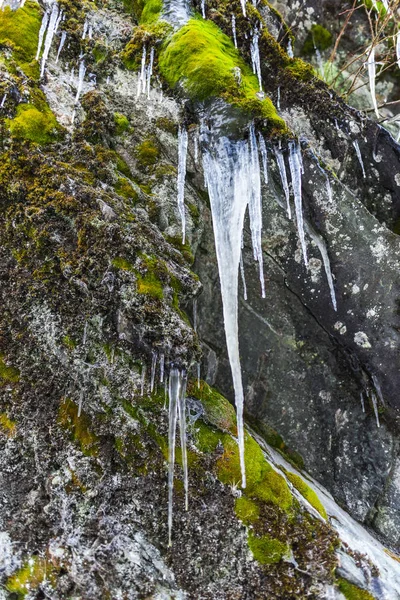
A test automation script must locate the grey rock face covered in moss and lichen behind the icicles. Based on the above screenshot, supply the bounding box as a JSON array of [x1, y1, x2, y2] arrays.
[[0, 0, 400, 600]]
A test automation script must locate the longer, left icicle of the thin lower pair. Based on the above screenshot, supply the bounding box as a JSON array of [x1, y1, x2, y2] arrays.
[[168, 369, 181, 546]]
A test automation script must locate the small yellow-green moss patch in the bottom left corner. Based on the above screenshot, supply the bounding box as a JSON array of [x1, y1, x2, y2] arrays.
[[6, 556, 58, 600]]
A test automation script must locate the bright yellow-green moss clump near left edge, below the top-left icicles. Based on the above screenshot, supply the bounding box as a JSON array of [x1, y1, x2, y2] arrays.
[[8, 104, 58, 145]]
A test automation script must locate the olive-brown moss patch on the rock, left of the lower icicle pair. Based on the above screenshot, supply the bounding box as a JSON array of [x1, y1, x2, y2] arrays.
[[58, 398, 99, 456]]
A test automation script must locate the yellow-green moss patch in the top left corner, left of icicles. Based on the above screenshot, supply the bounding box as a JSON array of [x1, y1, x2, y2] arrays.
[[0, 0, 42, 68]]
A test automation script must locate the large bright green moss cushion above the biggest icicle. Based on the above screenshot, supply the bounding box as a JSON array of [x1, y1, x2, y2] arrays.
[[159, 19, 286, 132]]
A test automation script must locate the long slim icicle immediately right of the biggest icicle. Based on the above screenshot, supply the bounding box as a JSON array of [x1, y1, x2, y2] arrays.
[[248, 123, 265, 298]]
